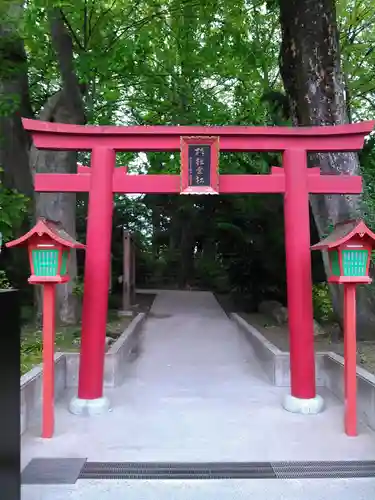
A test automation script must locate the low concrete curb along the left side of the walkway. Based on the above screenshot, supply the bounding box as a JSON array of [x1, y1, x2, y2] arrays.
[[20, 313, 146, 435]]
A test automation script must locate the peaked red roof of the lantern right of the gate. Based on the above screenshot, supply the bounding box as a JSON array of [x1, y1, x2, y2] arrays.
[[311, 219, 375, 250]]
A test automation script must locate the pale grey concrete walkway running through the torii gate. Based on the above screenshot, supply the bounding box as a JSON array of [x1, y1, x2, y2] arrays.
[[22, 291, 375, 500]]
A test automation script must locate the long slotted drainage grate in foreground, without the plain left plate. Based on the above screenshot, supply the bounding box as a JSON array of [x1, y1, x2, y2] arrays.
[[79, 461, 375, 479]]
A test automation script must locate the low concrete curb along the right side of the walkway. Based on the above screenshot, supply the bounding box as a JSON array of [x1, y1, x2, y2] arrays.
[[230, 313, 375, 430]]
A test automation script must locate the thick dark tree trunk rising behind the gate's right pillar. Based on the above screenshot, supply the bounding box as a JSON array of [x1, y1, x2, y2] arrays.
[[280, 0, 375, 338]]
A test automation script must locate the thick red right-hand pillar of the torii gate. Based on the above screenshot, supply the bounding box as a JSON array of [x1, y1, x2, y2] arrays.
[[283, 150, 316, 399]]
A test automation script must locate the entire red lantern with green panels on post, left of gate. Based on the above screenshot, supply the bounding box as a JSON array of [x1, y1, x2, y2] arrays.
[[6, 218, 85, 438]]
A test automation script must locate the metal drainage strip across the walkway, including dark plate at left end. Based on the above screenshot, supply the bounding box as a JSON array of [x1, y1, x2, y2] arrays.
[[21, 458, 375, 484]]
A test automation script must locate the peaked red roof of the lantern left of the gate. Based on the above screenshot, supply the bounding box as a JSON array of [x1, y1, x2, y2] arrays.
[[6, 217, 85, 249]]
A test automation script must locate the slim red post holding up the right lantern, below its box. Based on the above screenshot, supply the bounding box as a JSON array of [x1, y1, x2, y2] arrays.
[[344, 283, 357, 436]]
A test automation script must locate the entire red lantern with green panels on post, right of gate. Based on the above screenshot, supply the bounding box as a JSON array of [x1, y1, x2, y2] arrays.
[[312, 220, 375, 436]]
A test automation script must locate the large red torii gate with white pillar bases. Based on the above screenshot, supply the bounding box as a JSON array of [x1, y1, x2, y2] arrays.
[[23, 119, 375, 414]]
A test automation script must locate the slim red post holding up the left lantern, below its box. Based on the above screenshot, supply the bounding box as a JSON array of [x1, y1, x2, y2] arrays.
[[42, 283, 55, 438]]
